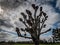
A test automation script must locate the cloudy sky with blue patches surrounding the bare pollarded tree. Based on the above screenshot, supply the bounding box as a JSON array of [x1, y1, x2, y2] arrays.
[[0, 0, 60, 41]]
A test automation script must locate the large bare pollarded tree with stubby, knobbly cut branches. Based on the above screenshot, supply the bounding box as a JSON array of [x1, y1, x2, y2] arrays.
[[16, 4, 51, 45]]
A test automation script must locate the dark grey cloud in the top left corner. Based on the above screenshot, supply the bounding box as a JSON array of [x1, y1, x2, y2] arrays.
[[0, 0, 25, 8]]
